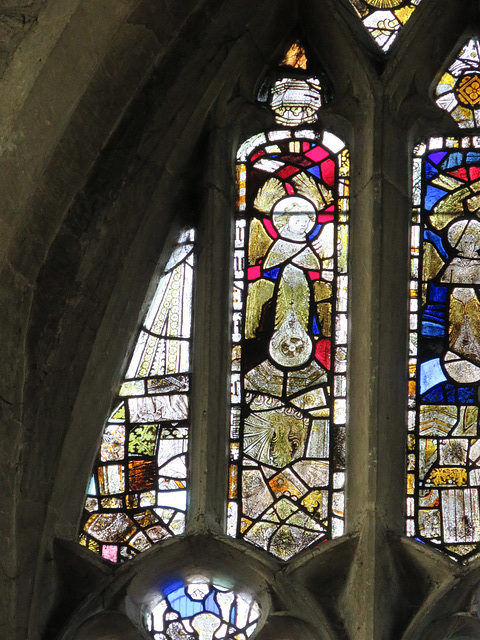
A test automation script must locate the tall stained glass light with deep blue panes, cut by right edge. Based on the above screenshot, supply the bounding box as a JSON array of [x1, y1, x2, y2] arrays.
[[407, 136, 480, 560]]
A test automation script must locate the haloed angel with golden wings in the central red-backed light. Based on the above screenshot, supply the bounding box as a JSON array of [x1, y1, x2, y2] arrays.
[[246, 173, 334, 368]]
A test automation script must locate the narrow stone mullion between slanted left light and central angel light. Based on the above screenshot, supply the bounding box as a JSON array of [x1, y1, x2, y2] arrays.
[[187, 127, 233, 534]]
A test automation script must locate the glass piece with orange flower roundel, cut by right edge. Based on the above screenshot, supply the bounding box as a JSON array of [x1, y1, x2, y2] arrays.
[[436, 39, 480, 128]]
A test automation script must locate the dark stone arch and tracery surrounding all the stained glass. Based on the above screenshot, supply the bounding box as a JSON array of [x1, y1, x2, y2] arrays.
[[0, 0, 480, 640]]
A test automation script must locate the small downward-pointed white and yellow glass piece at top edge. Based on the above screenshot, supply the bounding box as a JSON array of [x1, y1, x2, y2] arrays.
[[350, 0, 421, 52]]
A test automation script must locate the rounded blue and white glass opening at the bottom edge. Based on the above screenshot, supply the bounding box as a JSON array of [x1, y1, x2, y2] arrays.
[[145, 576, 260, 640]]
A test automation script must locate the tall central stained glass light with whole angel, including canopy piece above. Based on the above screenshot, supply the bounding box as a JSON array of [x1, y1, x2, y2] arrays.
[[228, 51, 349, 560]]
